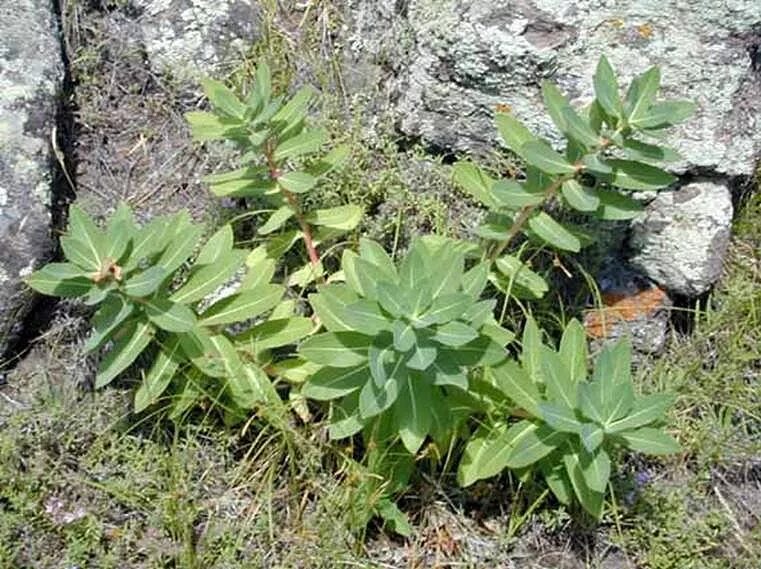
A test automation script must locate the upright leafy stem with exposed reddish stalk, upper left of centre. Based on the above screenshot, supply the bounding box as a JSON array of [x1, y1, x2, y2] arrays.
[[186, 63, 362, 286]]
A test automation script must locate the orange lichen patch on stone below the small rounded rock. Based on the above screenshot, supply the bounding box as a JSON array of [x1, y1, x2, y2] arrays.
[[584, 287, 668, 338]]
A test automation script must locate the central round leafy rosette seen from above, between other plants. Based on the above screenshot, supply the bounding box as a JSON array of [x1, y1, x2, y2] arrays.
[[299, 237, 513, 454]]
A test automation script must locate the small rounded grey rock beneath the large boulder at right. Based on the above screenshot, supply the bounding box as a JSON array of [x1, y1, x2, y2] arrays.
[[629, 180, 733, 297]]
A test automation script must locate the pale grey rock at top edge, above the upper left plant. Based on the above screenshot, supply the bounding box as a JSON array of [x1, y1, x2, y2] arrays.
[[133, 0, 260, 79]]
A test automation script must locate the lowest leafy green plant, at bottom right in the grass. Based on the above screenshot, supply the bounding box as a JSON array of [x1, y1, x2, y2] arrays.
[[458, 319, 679, 518]]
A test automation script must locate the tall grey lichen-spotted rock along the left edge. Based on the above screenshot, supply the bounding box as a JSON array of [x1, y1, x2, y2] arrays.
[[0, 0, 63, 355]]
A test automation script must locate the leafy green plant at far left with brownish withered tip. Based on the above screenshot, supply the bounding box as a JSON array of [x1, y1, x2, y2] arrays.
[[27, 204, 312, 420]]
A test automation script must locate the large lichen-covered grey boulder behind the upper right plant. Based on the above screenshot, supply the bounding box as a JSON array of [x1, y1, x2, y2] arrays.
[[345, 0, 761, 176]]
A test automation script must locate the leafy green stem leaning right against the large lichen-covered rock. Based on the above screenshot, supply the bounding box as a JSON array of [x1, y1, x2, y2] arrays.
[[454, 56, 695, 298]]
